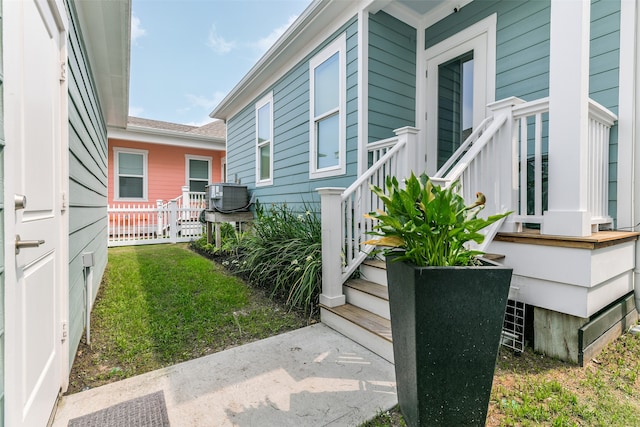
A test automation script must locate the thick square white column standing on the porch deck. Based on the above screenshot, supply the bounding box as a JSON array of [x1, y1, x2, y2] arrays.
[[541, 0, 591, 236]]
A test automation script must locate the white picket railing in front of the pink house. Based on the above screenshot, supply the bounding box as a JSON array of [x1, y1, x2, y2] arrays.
[[107, 187, 206, 247]]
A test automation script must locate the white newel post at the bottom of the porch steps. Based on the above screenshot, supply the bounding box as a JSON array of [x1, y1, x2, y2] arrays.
[[317, 187, 346, 307]]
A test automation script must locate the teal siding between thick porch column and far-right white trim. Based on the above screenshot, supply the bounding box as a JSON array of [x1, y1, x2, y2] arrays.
[[589, 0, 620, 226]]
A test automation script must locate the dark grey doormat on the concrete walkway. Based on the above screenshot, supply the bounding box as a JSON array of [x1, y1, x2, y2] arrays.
[[68, 391, 169, 427]]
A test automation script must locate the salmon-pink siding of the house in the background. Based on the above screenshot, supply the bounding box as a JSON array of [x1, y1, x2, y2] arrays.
[[108, 138, 225, 204]]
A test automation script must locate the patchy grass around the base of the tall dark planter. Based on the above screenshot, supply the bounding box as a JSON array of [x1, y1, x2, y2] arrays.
[[361, 333, 640, 427]]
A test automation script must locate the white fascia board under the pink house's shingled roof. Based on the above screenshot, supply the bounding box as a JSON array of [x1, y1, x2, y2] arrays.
[[107, 127, 226, 151]]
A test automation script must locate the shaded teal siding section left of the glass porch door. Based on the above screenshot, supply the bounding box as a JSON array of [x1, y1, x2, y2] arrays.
[[368, 12, 416, 142]]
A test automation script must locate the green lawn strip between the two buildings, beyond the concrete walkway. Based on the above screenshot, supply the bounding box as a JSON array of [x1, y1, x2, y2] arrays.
[[70, 245, 308, 392]]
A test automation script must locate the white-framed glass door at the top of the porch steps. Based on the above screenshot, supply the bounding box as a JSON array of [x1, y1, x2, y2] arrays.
[[419, 15, 496, 175]]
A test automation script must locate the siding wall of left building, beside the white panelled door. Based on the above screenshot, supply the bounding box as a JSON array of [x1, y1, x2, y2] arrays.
[[65, 2, 107, 368]]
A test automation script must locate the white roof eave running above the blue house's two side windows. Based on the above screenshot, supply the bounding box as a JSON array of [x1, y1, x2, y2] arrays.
[[209, 0, 364, 121]]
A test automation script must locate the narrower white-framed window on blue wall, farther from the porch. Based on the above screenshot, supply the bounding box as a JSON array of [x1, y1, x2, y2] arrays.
[[256, 94, 273, 185]]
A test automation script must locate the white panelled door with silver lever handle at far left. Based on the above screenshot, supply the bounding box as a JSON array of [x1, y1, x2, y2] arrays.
[[3, 0, 68, 426]]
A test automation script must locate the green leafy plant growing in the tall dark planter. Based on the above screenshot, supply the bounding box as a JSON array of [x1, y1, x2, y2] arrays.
[[365, 173, 511, 267]]
